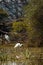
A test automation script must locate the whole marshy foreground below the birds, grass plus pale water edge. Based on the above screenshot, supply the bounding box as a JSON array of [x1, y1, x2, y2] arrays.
[[0, 44, 43, 65]]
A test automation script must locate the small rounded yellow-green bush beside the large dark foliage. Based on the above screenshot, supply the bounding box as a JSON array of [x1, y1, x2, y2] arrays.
[[13, 22, 27, 33]]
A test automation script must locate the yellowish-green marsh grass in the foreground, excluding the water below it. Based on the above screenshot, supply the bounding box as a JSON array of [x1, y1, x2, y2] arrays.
[[0, 45, 43, 60]]
